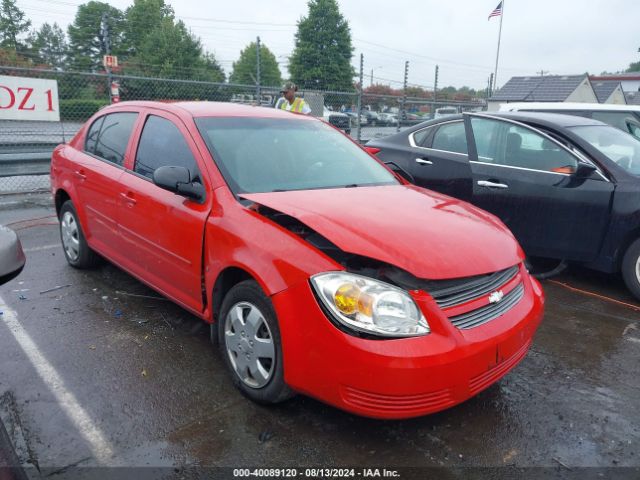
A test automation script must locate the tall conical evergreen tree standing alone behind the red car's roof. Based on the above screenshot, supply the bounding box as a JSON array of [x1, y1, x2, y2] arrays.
[[289, 0, 355, 90]]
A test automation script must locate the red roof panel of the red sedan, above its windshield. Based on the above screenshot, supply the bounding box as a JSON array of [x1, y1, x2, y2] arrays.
[[106, 101, 313, 120]]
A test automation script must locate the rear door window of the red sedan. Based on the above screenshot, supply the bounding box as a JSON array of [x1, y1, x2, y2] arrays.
[[88, 112, 138, 166]]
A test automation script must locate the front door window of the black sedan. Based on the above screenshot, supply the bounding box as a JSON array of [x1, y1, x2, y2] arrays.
[[471, 117, 578, 173]]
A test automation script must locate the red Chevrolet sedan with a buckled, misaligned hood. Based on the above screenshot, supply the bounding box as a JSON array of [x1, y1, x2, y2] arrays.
[[51, 102, 544, 418]]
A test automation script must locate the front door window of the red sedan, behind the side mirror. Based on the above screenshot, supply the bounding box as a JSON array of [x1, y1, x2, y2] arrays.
[[134, 115, 201, 182]]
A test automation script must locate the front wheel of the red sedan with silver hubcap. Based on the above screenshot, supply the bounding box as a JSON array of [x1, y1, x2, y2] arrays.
[[218, 280, 294, 404]]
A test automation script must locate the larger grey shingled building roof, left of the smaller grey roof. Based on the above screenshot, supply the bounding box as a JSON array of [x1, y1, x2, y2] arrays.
[[489, 74, 587, 102]]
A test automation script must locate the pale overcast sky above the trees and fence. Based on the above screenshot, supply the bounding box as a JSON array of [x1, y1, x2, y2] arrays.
[[17, 0, 640, 89]]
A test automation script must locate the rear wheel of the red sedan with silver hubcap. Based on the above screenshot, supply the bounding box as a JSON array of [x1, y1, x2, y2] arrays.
[[59, 200, 100, 268]]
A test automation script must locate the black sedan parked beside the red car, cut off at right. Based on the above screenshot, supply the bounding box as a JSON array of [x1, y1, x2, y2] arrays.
[[366, 112, 640, 299]]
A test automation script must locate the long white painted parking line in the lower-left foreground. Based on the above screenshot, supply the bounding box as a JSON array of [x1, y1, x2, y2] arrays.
[[0, 297, 115, 465]]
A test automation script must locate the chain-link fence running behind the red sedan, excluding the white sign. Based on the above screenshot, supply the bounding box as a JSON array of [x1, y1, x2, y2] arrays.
[[0, 66, 480, 194]]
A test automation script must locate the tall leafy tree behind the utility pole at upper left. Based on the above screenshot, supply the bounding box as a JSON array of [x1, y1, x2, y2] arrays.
[[68, 1, 129, 71]]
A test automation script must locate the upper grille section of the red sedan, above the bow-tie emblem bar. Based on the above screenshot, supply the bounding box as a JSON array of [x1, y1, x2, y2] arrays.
[[429, 265, 518, 308]]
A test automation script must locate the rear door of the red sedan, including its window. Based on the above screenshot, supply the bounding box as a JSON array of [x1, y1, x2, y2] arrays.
[[72, 112, 138, 258]]
